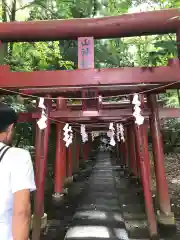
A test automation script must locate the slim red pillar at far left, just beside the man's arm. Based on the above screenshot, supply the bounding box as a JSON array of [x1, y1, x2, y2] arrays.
[[32, 100, 52, 240]]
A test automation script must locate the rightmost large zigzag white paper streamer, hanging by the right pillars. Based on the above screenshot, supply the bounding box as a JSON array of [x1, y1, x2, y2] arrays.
[[132, 93, 144, 125]]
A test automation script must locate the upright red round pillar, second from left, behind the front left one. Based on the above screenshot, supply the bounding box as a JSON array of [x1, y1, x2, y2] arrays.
[[54, 97, 66, 193]]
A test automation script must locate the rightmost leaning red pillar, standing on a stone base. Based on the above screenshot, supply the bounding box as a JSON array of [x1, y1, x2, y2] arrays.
[[148, 95, 171, 215]]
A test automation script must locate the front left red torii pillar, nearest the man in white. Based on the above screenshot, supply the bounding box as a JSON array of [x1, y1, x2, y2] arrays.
[[32, 99, 52, 240]]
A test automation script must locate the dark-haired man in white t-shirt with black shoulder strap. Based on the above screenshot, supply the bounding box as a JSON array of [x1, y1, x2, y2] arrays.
[[0, 104, 36, 240]]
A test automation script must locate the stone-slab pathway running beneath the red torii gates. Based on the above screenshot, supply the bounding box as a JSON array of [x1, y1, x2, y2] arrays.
[[65, 153, 148, 240]]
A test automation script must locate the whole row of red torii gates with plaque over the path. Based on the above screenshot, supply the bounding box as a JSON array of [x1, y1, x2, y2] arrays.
[[0, 9, 180, 240]]
